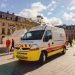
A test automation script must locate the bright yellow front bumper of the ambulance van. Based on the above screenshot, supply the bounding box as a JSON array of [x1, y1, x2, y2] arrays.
[[13, 49, 41, 61]]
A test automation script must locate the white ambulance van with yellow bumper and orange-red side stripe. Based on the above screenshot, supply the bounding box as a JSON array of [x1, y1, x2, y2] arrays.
[[14, 25, 66, 63]]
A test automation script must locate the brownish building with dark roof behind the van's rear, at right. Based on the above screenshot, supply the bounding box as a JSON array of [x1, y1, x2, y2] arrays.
[[57, 25, 75, 39]]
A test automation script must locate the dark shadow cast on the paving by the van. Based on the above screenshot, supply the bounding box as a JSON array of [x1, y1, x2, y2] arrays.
[[0, 54, 62, 75]]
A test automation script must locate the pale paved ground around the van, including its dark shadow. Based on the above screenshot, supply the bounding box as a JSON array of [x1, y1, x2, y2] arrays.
[[0, 46, 75, 75]]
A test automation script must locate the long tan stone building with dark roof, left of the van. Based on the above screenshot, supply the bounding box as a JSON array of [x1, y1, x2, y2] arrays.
[[0, 11, 39, 44]]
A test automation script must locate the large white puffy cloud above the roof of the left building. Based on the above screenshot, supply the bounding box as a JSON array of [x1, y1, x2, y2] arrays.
[[18, 2, 46, 19]]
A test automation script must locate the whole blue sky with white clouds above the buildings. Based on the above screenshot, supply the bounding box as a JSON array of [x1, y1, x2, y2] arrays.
[[0, 0, 75, 24]]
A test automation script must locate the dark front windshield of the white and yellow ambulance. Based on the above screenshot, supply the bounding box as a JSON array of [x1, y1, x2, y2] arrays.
[[21, 30, 45, 40]]
